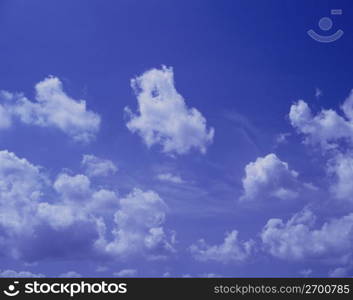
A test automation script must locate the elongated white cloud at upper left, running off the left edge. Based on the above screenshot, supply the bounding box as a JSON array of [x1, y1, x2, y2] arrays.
[[0, 77, 101, 142]]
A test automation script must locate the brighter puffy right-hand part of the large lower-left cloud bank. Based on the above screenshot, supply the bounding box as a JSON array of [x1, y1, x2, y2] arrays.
[[43, 179, 175, 258]]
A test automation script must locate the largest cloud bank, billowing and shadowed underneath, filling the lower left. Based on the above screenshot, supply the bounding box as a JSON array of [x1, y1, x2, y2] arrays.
[[0, 151, 175, 262]]
